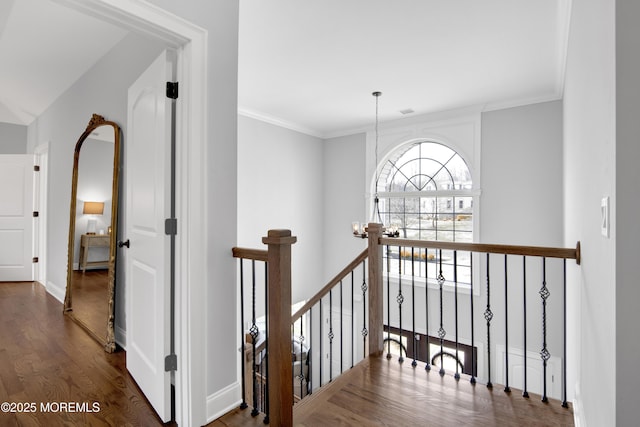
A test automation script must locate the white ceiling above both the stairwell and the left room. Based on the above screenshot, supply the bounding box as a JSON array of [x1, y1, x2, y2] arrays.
[[0, 0, 570, 137]]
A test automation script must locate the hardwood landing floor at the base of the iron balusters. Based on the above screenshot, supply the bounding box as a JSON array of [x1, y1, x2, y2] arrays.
[[208, 358, 574, 427]]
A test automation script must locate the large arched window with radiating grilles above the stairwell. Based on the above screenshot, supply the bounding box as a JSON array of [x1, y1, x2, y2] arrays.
[[376, 141, 474, 285]]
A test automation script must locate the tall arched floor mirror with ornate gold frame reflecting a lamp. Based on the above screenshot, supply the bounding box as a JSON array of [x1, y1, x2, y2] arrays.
[[64, 114, 120, 353]]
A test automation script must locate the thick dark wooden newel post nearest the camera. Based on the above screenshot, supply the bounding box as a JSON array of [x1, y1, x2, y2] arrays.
[[262, 230, 297, 427]]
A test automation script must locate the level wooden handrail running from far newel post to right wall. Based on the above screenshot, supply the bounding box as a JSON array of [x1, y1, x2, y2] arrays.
[[379, 237, 580, 264]]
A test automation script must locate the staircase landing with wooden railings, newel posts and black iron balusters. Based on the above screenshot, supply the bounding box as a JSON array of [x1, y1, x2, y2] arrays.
[[230, 224, 580, 426]]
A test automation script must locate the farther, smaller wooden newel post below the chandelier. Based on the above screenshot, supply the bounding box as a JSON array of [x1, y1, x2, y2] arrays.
[[367, 223, 384, 356]]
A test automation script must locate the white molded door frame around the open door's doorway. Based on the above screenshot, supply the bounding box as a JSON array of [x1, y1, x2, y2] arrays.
[[55, 0, 208, 425]]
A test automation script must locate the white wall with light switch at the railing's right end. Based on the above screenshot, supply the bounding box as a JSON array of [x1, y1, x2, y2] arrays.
[[564, 0, 616, 426]]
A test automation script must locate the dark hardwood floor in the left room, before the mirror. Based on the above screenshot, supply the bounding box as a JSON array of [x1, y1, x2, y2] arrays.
[[0, 282, 170, 427]]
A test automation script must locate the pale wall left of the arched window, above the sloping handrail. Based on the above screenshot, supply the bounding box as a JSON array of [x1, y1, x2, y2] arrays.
[[238, 116, 322, 302]]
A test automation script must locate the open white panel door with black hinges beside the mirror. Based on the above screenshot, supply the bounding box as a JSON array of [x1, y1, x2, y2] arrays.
[[121, 52, 172, 422]]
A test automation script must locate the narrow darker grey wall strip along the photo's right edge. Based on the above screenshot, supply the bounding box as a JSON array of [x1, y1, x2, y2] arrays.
[[614, 0, 640, 426]]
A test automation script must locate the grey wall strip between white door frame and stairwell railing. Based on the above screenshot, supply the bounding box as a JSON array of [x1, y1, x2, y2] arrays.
[[145, 0, 239, 413]]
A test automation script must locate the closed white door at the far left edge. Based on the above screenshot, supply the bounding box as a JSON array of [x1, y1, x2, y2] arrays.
[[0, 154, 34, 282]]
